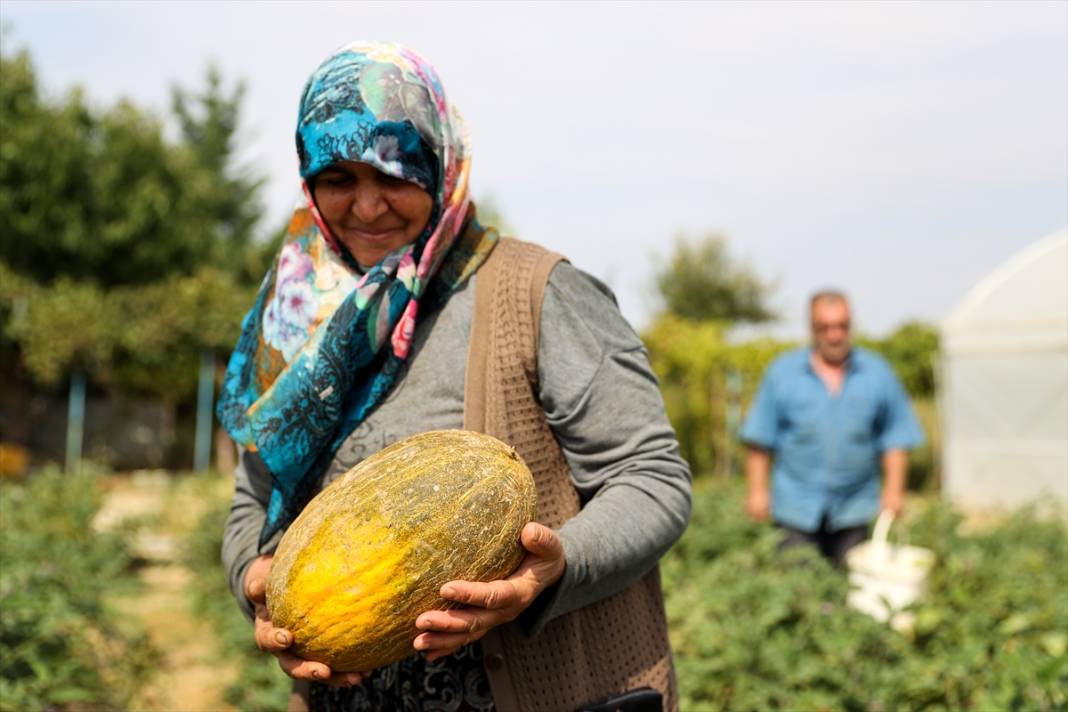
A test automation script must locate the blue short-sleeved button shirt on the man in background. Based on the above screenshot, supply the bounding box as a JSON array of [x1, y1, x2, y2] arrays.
[[741, 348, 924, 532]]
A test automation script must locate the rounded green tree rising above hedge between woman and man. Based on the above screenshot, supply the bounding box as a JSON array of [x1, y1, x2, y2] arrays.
[[656, 235, 775, 322]]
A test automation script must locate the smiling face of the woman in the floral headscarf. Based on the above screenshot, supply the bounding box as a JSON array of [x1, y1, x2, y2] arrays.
[[312, 161, 434, 267]]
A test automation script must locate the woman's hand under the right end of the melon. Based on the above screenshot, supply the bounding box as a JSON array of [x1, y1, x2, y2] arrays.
[[414, 522, 565, 660]]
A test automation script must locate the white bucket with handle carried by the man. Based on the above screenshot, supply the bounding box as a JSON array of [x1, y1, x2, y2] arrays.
[[846, 511, 935, 631]]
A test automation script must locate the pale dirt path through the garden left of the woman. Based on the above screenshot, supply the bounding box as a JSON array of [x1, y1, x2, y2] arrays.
[[94, 472, 234, 712]]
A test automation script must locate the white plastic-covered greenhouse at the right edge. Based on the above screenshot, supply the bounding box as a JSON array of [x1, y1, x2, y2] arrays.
[[940, 230, 1068, 517]]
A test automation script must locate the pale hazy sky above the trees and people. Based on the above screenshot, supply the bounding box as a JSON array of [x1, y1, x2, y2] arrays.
[[0, 0, 1068, 338]]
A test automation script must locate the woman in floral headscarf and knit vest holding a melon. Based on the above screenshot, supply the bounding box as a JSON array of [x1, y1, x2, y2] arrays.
[[219, 43, 690, 710]]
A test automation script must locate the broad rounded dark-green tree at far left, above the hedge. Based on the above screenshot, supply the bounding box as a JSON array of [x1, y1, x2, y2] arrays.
[[0, 53, 213, 285]]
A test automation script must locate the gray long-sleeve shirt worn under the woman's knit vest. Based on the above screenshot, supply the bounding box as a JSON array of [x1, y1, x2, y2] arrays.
[[222, 263, 690, 634]]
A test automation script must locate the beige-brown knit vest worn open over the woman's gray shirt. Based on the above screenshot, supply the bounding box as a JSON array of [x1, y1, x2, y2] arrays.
[[464, 238, 678, 712]]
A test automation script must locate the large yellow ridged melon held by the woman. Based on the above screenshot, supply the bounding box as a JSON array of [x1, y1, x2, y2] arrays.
[[267, 430, 536, 671]]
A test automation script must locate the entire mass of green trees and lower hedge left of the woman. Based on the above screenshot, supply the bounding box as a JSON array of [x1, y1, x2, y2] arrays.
[[0, 44, 267, 402]]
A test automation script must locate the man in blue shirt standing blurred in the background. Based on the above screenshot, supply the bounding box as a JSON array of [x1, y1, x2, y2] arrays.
[[741, 290, 924, 566]]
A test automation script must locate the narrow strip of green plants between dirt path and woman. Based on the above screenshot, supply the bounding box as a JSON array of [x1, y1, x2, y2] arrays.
[[186, 503, 293, 712]]
